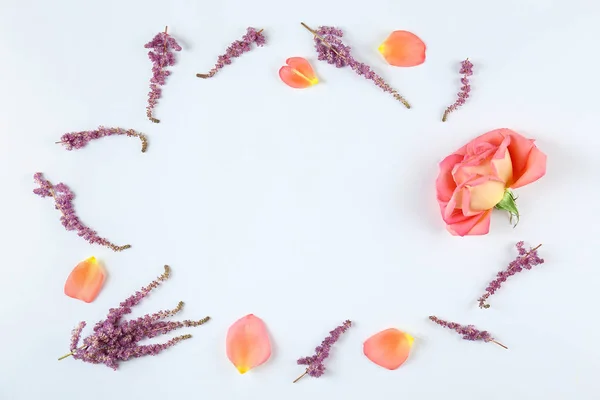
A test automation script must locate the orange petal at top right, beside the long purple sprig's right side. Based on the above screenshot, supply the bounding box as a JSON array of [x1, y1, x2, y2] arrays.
[[379, 31, 426, 67]]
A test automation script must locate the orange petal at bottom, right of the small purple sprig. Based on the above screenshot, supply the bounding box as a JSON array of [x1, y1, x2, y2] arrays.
[[363, 328, 415, 370]]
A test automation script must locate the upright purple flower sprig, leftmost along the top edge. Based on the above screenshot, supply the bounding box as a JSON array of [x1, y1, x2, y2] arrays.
[[144, 27, 181, 123]]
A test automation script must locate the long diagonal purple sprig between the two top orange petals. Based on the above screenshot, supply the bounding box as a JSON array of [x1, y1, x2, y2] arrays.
[[301, 22, 410, 108]]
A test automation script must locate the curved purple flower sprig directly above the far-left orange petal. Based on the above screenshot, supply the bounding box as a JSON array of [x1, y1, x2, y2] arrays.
[[33, 172, 131, 252]]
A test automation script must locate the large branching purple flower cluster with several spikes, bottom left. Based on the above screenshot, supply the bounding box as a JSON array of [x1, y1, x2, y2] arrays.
[[59, 265, 210, 370]]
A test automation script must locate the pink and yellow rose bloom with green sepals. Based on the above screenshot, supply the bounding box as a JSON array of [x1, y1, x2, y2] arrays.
[[435, 129, 546, 236]]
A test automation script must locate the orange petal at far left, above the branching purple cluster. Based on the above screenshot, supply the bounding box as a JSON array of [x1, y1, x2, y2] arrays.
[[65, 257, 106, 303]]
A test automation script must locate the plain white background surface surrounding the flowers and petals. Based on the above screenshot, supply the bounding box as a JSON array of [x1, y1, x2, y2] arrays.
[[0, 0, 600, 400]]
